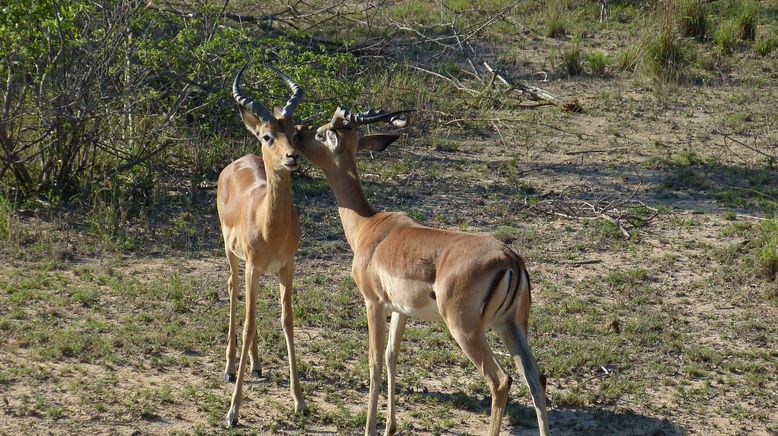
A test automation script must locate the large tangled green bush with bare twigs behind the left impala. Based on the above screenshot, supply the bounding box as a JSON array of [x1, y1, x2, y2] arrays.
[[0, 0, 361, 204]]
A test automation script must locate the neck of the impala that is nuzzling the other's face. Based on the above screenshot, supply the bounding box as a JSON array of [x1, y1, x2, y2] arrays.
[[325, 156, 376, 251]]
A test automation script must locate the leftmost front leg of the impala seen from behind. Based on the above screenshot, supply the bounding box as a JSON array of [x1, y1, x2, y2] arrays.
[[365, 301, 386, 435]]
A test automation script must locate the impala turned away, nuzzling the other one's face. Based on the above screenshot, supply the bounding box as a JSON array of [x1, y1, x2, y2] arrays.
[[298, 108, 548, 435]]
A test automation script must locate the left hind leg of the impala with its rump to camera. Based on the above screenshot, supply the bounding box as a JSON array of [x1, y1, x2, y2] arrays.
[[449, 323, 511, 436]]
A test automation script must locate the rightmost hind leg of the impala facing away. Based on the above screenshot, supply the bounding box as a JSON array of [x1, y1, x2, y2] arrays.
[[498, 323, 548, 436]]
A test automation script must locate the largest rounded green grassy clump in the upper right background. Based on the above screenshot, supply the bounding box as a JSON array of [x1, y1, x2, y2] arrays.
[[643, 29, 690, 81]]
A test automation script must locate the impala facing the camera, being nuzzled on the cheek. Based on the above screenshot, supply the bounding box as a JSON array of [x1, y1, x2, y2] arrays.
[[216, 66, 305, 427]]
